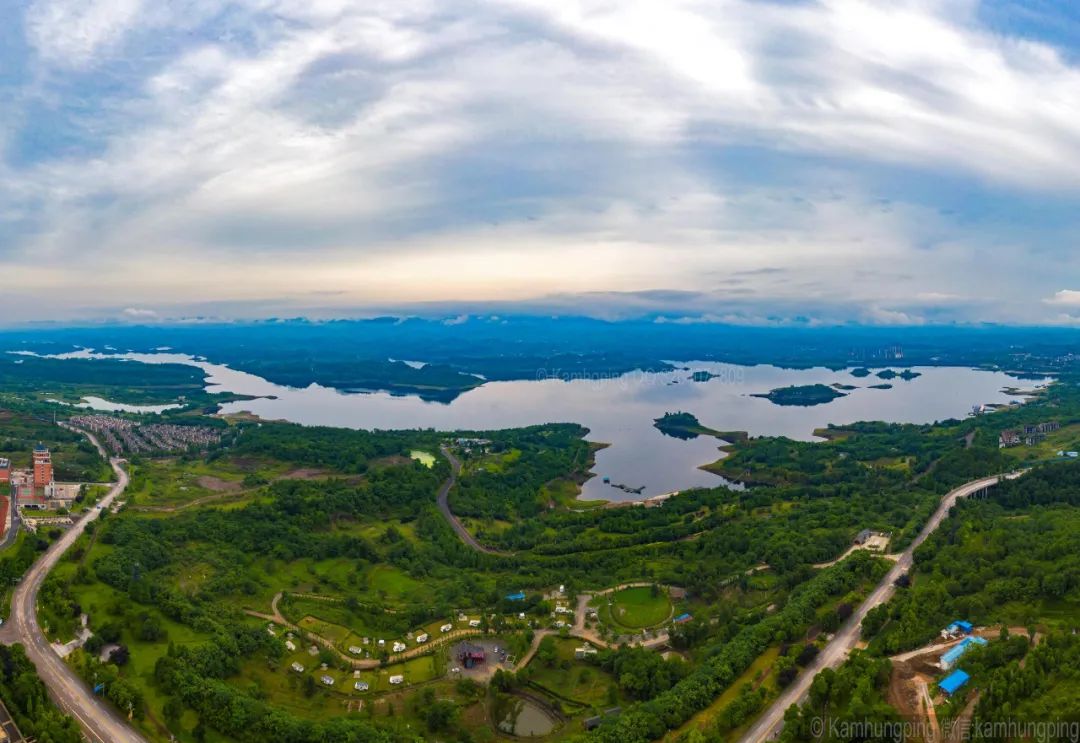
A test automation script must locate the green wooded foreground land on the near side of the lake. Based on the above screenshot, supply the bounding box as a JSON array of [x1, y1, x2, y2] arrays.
[[0, 347, 1080, 743]]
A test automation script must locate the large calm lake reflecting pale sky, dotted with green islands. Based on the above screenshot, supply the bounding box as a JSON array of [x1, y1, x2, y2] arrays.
[[38, 352, 1041, 500]]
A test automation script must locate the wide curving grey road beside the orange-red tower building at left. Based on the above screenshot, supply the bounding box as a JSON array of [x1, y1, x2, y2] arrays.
[[0, 431, 146, 743]]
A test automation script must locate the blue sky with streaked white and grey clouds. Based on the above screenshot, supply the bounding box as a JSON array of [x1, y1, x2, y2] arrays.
[[0, 0, 1080, 324]]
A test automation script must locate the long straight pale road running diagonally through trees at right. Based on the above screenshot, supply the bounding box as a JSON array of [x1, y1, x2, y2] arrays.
[[741, 472, 1022, 743]]
